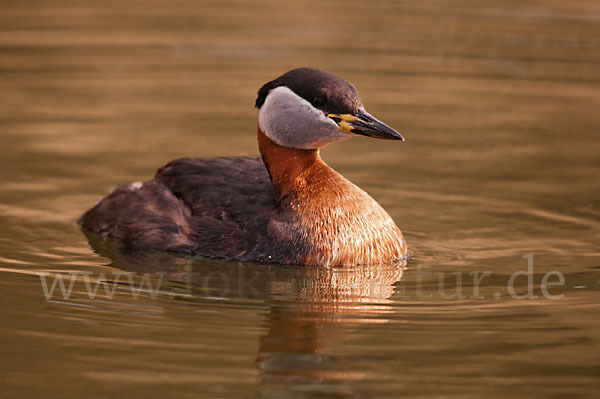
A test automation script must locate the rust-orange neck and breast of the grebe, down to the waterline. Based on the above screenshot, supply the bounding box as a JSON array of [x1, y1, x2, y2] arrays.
[[258, 126, 406, 265]]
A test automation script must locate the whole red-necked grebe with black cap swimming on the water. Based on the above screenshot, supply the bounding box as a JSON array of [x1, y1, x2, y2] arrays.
[[80, 68, 408, 266]]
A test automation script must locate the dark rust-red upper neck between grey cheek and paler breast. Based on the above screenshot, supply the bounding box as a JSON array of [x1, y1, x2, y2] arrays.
[[257, 126, 323, 197]]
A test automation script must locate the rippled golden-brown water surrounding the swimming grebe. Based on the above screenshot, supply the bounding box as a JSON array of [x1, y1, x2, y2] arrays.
[[0, 0, 600, 398]]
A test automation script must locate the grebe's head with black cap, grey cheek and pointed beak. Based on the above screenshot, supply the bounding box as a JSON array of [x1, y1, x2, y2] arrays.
[[256, 68, 404, 149]]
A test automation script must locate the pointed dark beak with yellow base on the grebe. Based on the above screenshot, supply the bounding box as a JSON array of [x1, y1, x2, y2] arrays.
[[327, 109, 404, 141]]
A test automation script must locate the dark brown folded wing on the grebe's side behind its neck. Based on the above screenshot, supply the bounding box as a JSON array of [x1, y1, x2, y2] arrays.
[[155, 156, 276, 259]]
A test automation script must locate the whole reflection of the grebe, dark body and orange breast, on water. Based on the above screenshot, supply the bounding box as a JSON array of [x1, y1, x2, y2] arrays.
[[82, 233, 405, 394]]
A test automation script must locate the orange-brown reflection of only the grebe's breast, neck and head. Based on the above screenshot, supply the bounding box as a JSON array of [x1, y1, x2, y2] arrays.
[[256, 263, 404, 393]]
